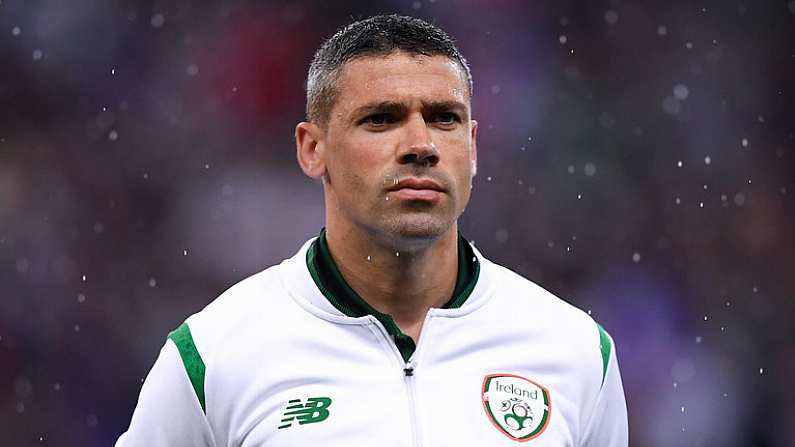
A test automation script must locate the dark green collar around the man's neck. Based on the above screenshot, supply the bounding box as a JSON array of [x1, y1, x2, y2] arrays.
[[306, 228, 480, 362]]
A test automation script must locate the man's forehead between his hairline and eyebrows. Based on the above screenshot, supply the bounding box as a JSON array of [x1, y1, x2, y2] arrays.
[[333, 52, 469, 115]]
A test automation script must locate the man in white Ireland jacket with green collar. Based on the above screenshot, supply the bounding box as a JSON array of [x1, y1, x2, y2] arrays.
[[117, 16, 627, 447]]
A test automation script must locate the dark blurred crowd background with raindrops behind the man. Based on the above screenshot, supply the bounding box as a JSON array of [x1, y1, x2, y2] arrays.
[[0, 0, 795, 447]]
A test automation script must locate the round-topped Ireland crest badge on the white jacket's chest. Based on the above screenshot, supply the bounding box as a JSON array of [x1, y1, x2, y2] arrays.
[[481, 374, 552, 442]]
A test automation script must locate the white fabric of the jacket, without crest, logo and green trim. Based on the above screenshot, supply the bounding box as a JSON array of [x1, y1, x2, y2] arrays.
[[116, 236, 628, 447]]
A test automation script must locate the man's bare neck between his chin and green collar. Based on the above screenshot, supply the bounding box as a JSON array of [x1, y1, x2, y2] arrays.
[[326, 222, 458, 341]]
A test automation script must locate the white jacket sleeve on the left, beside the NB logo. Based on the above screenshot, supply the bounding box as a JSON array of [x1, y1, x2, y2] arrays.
[[116, 325, 216, 447]]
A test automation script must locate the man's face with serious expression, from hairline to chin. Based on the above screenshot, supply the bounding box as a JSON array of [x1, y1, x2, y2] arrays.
[[322, 52, 477, 247]]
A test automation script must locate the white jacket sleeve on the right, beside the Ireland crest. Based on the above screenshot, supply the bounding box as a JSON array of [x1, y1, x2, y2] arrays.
[[580, 326, 629, 447]]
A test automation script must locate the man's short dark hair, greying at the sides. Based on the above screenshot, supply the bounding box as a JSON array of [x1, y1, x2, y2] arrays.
[[306, 14, 472, 125]]
